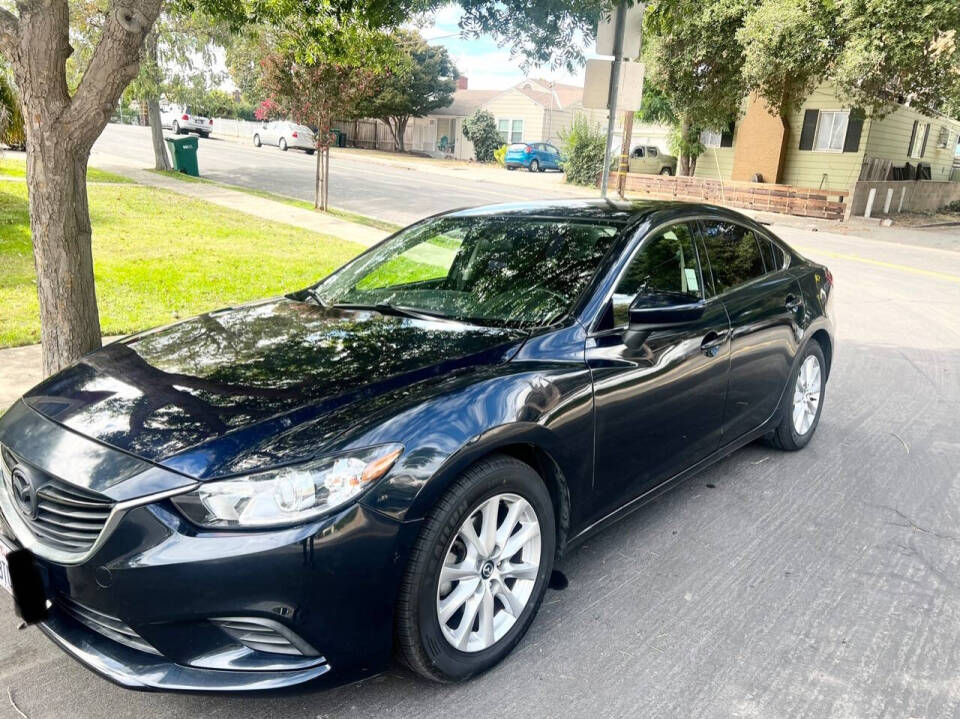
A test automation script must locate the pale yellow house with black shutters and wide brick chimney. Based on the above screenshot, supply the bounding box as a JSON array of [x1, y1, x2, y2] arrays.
[[696, 84, 960, 190]]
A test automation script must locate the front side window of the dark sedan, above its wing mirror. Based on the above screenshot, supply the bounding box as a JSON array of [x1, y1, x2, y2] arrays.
[[613, 223, 703, 327]]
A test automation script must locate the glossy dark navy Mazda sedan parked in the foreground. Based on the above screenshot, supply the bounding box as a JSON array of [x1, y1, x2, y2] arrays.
[[0, 201, 834, 690]]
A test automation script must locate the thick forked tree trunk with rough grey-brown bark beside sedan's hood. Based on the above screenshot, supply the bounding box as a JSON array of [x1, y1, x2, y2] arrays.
[[0, 0, 161, 374]]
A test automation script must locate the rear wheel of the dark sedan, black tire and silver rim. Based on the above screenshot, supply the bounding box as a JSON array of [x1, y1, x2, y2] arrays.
[[765, 340, 827, 452]]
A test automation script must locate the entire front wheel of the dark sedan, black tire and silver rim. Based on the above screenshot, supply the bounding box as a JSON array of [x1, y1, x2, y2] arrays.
[[395, 455, 556, 682]]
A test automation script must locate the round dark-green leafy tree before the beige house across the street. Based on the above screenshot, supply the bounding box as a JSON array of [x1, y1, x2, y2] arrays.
[[361, 30, 459, 152]]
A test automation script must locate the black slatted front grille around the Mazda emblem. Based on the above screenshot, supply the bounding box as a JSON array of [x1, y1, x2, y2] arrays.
[[2, 449, 113, 554]]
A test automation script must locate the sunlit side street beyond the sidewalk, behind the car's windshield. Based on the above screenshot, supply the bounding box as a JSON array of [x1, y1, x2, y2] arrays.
[[92, 125, 582, 225]]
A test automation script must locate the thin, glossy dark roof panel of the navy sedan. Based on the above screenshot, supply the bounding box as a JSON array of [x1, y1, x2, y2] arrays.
[[442, 199, 753, 225]]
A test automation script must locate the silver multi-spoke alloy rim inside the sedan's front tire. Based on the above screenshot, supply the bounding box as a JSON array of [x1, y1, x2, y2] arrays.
[[437, 494, 541, 652]]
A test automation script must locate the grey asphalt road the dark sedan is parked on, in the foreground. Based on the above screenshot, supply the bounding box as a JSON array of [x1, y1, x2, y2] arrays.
[[0, 132, 960, 719]]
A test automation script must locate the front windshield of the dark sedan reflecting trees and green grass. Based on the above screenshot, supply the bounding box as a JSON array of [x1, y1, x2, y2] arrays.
[[313, 216, 619, 327]]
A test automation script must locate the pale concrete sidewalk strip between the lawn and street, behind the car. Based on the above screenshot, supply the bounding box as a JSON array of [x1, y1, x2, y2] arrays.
[[97, 162, 389, 247]]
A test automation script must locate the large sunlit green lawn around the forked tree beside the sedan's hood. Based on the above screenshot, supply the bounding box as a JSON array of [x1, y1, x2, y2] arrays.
[[0, 181, 364, 347]]
